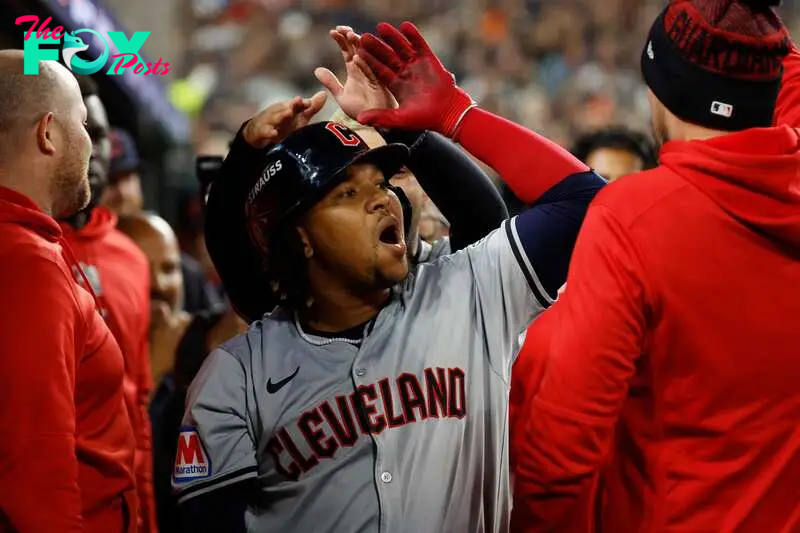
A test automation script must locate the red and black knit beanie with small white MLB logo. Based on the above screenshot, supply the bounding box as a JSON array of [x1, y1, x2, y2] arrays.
[[642, 0, 791, 131]]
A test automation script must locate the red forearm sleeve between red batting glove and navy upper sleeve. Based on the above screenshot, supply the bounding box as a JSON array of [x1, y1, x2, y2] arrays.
[[455, 108, 589, 204]]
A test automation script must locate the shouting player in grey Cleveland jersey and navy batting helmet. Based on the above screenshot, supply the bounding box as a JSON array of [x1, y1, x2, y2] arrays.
[[173, 25, 604, 533]]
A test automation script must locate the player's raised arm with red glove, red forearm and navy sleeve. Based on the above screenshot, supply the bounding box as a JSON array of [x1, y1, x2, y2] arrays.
[[359, 22, 605, 306]]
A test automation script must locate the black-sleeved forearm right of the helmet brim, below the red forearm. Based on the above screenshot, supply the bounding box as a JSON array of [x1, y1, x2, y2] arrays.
[[390, 132, 508, 252]]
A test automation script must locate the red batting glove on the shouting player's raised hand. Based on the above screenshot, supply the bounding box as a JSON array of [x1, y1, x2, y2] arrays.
[[358, 22, 475, 138]]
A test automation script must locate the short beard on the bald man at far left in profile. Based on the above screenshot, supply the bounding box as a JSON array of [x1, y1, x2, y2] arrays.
[[51, 131, 91, 218]]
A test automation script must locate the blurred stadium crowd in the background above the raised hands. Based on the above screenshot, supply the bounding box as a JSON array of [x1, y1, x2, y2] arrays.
[[189, 0, 800, 151]]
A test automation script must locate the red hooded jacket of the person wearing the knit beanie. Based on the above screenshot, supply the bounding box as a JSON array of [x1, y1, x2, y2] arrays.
[[512, 127, 800, 533]]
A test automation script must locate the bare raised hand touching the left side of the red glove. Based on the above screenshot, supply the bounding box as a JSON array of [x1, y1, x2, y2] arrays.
[[314, 26, 397, 120]]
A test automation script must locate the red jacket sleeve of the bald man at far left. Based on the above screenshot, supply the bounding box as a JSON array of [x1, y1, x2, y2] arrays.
[[0, 258, 84, 533]]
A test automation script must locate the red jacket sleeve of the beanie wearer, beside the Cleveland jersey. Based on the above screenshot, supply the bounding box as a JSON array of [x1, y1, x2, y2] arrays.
[[512, 205, 647, 532]]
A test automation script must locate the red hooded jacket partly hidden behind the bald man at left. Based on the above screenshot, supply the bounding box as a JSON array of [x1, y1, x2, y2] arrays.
[[61, 206, 158, 533]]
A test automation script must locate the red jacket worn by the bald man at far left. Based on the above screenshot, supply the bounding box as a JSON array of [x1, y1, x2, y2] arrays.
[[0, 187, 137, 533]]
